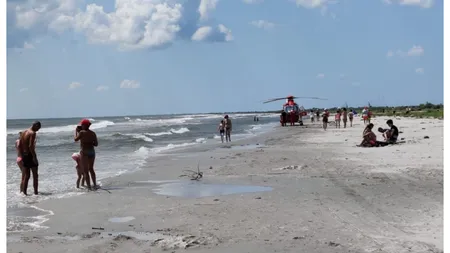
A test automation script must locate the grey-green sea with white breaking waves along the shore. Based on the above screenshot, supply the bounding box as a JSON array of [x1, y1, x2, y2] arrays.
[[7, 114, 279, 232]]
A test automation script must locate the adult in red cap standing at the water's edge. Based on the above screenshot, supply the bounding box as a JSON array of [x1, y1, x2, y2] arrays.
[[74, 119, 98, 190]]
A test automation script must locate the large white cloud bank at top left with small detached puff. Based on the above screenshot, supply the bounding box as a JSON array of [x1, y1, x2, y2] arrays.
[[8, 0, 232, 50]]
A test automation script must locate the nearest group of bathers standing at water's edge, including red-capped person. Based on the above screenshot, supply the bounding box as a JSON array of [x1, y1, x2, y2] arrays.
[[15, 119, 98, 195]]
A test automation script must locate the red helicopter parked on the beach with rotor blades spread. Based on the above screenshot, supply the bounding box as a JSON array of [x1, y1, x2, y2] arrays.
[[263, 95, 326, 126]]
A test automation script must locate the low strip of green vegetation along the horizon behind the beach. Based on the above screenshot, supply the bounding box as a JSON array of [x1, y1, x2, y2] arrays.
[[217, 102, 444, 118]]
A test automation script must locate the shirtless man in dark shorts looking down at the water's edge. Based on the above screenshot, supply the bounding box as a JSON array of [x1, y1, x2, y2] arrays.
[[18, 121, 41, 195]]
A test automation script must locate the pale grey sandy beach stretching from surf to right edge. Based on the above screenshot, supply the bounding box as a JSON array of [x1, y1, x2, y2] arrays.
[[8, 117, 443, 253]]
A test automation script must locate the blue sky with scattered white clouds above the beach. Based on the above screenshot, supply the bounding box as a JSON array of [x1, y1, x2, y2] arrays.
[[7, 0, 443, 119]]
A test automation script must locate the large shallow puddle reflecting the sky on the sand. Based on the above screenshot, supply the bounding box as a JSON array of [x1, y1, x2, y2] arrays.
[[153, 182, 272, 198]]
